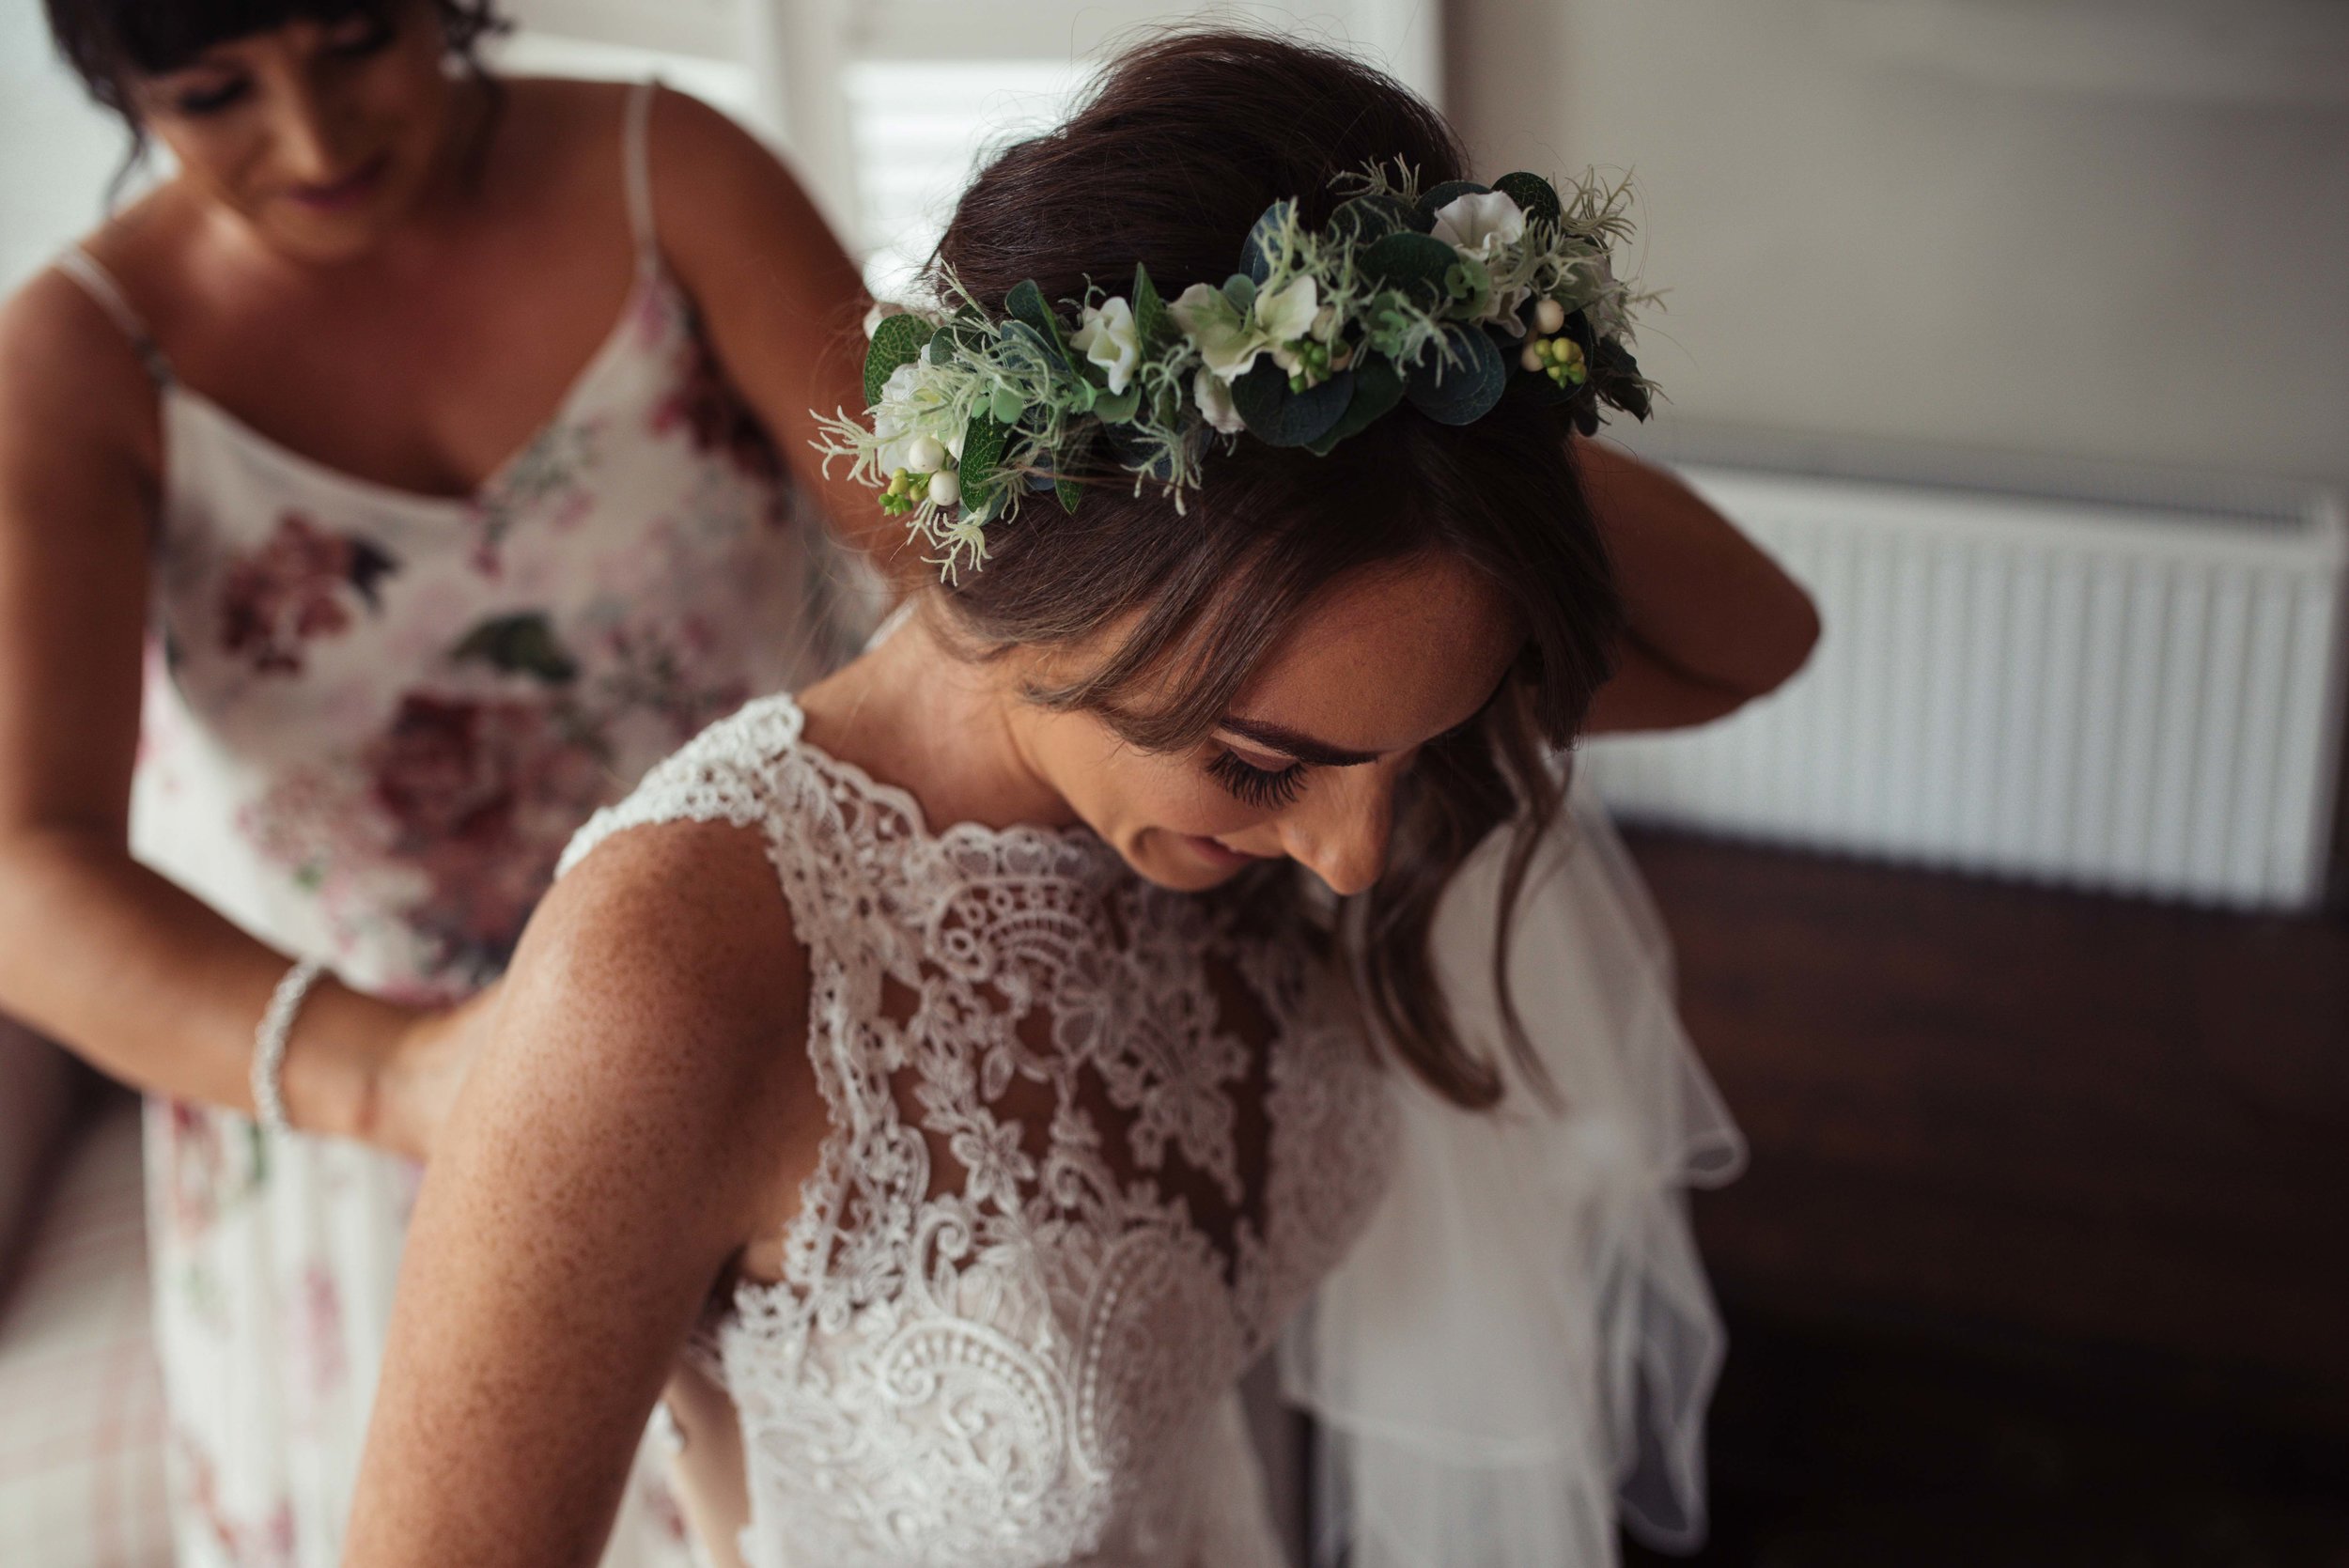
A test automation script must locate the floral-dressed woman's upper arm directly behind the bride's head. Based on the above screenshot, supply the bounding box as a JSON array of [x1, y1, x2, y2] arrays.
[[651, 91, 924, 586]]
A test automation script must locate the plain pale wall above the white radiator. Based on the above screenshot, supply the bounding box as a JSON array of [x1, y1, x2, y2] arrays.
[[1447, 0, 2349, 495]]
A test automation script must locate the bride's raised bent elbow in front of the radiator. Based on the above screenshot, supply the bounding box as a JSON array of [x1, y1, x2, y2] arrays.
[[1574, 442, 1818, 733]]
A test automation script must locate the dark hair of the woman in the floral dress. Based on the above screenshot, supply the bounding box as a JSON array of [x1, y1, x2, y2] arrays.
[[42, 0, 506, 171]]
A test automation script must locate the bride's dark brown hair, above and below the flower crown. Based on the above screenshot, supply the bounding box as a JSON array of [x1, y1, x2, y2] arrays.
[[933, 33, 1624, 1106]]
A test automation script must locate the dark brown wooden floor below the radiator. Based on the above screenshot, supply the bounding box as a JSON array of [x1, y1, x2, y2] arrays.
[[1630, 833, 2349, 1566]]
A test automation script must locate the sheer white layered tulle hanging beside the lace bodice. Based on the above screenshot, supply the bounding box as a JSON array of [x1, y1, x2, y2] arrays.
[[1283, 780, 1746, 1568]]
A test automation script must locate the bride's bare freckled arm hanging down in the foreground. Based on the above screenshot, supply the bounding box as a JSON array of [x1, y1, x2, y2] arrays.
[[343, 824, 822, 1568]]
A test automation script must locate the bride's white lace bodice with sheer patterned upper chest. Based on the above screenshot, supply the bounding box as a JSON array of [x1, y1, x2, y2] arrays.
[[564, 697, 1391, 1568]]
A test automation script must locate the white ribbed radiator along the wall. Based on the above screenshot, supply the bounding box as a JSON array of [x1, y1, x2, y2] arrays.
[[1586, 453, 2349, 908]]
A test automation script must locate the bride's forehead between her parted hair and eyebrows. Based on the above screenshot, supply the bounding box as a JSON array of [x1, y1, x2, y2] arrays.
[[1236, 556, 1525, 752]]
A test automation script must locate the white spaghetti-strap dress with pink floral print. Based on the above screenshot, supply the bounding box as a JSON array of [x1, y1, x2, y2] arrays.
[[64, 89, 860, 1568]]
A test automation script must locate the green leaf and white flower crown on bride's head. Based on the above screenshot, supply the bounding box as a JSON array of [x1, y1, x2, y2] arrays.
[[816, 164, 1657, 582]]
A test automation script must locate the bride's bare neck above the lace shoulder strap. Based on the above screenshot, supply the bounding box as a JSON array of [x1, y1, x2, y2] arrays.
[[799, 613, 1076, 829]]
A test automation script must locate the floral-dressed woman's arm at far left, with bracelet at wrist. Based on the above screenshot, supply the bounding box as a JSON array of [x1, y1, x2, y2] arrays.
[[0, 272, 462, 1153]]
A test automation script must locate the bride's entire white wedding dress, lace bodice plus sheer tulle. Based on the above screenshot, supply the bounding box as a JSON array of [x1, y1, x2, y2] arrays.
[[564, 697, 1741, 1568]]
